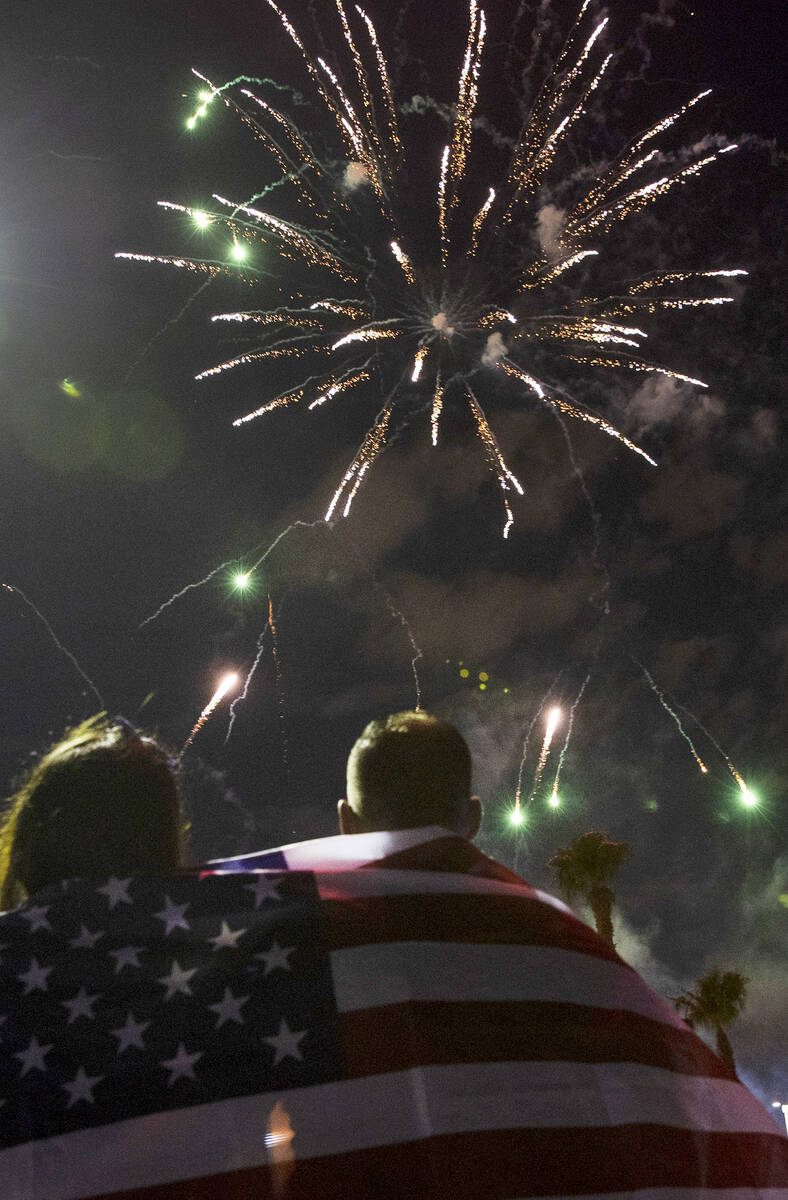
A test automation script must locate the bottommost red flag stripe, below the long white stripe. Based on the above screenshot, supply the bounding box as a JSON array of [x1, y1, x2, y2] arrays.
[[82, 1124, 788, 1200]]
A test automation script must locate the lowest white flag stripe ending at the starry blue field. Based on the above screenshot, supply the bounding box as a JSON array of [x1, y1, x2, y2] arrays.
[[331, 942, 686, 1030]]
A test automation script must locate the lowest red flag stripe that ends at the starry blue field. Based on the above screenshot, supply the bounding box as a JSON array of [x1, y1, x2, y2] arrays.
[[339, 1001, 735, 1082]]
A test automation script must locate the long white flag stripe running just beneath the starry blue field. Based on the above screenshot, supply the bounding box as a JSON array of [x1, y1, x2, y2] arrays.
[[0, 1062, 775, 1200]]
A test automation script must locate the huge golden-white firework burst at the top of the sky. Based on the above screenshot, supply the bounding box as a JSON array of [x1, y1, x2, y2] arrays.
[[119, 0, 746, 536]]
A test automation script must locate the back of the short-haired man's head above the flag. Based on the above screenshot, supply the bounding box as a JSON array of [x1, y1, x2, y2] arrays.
[[339, 712, 481, 838]]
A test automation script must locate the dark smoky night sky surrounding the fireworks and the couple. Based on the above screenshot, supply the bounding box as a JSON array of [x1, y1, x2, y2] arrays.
[[0, 0, 788, 1100]]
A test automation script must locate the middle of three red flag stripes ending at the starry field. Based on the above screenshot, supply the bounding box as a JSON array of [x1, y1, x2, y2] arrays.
[[323, 893, 626, 966]]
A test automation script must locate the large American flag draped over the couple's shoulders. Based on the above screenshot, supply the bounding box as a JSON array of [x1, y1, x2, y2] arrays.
[[0, 829, 788, 1200]]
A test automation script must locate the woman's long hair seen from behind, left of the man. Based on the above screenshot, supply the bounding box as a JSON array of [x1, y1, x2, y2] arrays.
[[0, 713, 185, 910]]
